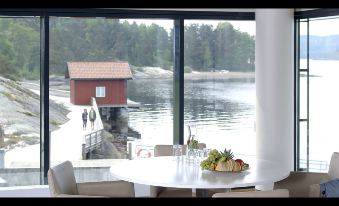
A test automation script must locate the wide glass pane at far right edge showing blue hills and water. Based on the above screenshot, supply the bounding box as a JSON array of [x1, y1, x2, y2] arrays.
[[310, 18, 339, 172]]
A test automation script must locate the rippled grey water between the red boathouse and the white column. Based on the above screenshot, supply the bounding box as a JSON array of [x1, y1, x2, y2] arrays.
[[128, 79, 256, 155]]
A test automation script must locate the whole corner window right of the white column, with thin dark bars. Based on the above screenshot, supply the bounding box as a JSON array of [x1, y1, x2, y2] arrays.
[[297, 16, 339, 172]]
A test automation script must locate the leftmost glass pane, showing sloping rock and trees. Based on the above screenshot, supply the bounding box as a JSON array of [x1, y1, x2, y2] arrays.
[[0, 17, 40, 187]]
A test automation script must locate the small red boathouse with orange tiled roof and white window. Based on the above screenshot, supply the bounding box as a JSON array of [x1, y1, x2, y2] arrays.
[[66, 61, 133, 107]]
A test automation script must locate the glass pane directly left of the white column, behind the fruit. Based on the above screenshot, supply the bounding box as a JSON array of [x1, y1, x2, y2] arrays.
[[184, 20, 256, 155]]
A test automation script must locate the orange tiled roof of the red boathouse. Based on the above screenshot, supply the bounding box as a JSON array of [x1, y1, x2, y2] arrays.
[[66, 62, 133, 79]]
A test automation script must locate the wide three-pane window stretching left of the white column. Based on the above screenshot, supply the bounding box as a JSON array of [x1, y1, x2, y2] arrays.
[[0, 9, 255, 186]]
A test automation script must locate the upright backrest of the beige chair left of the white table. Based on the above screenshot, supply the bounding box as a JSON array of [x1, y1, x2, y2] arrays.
[[48, 161, 78, 197]]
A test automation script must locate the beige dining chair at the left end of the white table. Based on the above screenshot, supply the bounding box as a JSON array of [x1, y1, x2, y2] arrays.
[[47, 161, 135, 197]]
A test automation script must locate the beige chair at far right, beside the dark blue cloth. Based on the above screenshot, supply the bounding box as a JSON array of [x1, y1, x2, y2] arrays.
[[274, 152, 339, 197]]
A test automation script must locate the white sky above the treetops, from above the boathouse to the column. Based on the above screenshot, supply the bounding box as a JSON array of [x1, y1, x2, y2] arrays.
[[121, 19, 255, 36]]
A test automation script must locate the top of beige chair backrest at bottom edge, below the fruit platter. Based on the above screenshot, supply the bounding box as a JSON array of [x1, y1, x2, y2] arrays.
[[212, 189, 290, 197]]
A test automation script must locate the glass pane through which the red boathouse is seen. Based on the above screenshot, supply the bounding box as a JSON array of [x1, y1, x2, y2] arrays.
[[50, 17, 173, 182]]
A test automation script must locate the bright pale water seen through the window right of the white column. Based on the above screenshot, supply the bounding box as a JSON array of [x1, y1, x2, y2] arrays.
[[300, 59, 339, 172]]
